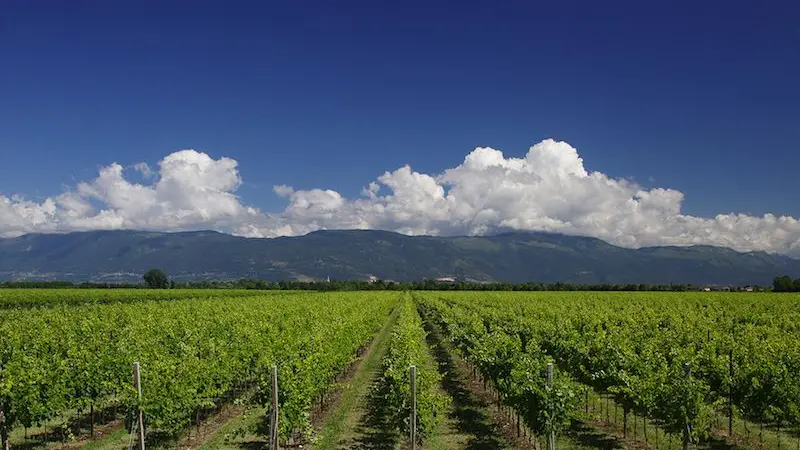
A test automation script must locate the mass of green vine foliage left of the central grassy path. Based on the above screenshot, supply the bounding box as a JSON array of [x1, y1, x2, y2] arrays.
[[0, 293, 393, 446]]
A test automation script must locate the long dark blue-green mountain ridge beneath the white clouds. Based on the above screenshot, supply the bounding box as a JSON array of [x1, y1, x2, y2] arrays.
[[0, 230, 800, 285]]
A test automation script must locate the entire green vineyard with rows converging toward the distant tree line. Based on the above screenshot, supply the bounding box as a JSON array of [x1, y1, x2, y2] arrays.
[[0, 290, 800, 449]]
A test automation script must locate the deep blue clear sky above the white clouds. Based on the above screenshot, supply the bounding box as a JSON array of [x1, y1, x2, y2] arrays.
[[0, 0, 800, 253]]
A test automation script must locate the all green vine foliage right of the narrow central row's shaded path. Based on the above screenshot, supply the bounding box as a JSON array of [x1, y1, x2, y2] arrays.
[[415, 292, 800, 441]]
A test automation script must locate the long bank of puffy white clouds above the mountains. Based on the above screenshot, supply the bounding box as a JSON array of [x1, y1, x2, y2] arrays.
[[0, 139, 800, 257]]
